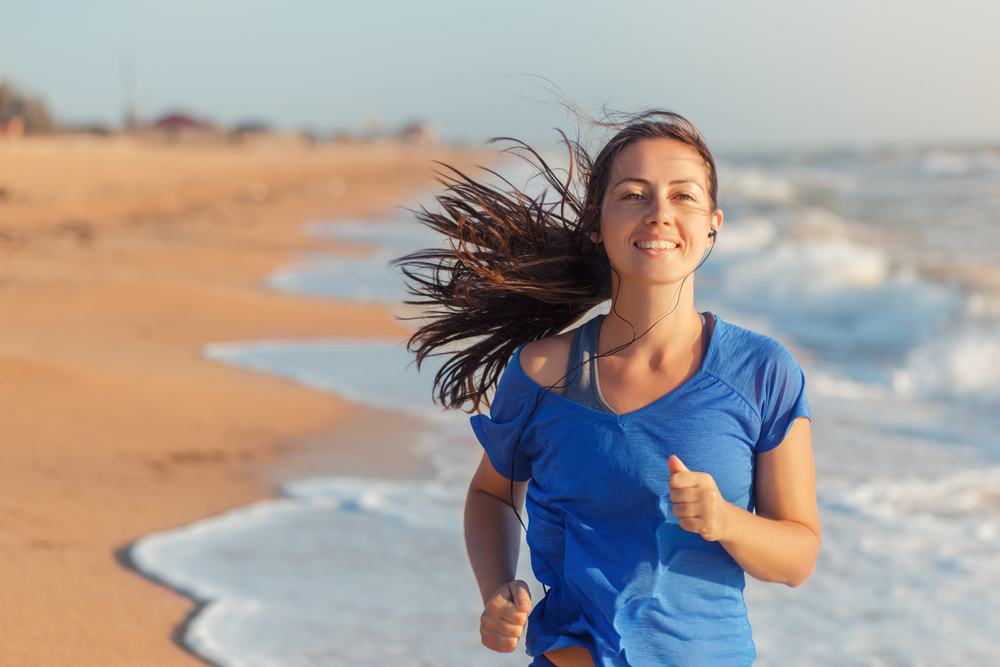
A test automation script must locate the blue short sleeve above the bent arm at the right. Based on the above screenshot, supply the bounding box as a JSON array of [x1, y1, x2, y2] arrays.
[[757, 345, 811, 454]]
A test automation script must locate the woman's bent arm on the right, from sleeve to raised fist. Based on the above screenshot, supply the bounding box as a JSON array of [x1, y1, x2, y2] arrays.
[[669, 417, 820, 586]]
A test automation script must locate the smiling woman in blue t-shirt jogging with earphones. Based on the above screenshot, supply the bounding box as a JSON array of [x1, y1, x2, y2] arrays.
[[402, 112, 820, 667]]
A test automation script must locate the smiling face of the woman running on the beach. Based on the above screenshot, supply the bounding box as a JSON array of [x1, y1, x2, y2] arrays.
[[594, 139, 722, 285]]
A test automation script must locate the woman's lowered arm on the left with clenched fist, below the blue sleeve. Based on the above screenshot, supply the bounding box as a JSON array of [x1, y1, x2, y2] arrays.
[[465, 454, 531, 653]]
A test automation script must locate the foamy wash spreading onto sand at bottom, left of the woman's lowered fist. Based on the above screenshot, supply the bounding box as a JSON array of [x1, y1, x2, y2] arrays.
[[132, 478, 541, 667]]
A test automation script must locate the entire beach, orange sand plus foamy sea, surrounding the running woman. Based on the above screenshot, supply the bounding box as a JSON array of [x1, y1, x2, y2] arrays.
[[0, 133, 1000, 667]]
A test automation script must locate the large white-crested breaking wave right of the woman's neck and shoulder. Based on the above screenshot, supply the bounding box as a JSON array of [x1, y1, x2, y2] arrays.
[[699, 223, 963, 374]]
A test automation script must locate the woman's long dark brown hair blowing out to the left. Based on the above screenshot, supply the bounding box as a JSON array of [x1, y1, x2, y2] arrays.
[[395, 111, 718, 410]]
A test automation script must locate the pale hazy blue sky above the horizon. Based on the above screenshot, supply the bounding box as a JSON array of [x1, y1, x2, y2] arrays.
[[0, 0, 1000, 149]]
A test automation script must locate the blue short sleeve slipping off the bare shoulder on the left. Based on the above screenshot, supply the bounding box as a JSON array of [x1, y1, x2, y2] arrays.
[[470, 350, 537, 482]]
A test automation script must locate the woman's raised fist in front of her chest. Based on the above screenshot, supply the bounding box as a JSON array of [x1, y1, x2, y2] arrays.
[[667, 456, 732, 542]]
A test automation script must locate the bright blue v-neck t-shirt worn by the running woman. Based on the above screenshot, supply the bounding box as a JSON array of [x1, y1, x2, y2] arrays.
[[472, 318, 809, 667]]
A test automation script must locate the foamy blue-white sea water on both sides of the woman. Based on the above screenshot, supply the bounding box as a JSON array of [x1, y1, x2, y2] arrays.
[[132, 149, 1000, 667]]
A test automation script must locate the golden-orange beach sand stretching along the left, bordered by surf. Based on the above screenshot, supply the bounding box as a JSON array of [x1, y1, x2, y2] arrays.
[[0, 137, 487, 666]]
